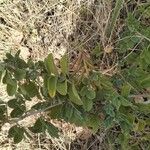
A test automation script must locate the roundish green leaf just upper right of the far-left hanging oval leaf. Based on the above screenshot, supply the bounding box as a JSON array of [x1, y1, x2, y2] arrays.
[[14, 68, 26, 81]]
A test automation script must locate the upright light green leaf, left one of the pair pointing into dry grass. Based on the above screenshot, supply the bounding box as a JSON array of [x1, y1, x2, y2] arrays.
[[44, 53, 58, 75]]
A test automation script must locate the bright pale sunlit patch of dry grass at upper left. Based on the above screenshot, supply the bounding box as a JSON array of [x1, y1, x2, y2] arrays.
[[0, 0, 78, 59]]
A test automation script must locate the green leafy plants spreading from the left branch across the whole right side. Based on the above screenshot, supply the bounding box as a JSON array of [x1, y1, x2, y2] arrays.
[[0, 0, 150, 150]]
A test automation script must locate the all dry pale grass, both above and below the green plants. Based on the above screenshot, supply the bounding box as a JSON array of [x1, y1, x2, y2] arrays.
[[0, 0, 116, 150]]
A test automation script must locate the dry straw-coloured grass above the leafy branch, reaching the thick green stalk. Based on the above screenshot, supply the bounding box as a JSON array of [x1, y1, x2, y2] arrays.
[[0, 0, 112, 59]]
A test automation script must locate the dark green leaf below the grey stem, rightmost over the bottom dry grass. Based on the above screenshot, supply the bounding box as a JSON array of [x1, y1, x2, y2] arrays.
[[45, 122, 59, 138]]
